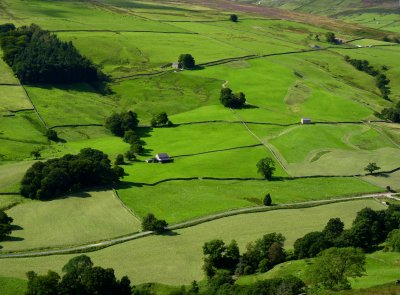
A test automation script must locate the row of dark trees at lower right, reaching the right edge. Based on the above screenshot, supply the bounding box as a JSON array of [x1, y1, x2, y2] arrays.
[[294, 205, 400, 259]]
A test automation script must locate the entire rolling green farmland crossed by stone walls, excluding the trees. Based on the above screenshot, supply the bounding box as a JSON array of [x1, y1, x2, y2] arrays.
[[0, 0, 400, 294]]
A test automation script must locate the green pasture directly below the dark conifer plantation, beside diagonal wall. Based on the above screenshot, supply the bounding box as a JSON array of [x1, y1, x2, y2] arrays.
[[26, 84, 116, 127]]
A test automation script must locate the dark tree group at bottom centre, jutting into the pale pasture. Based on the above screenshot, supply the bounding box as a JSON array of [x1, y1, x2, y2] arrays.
[[203, 233, 286, 278]]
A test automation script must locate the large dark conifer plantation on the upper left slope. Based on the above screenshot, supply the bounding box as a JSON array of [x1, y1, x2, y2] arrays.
[[1, 25, 104, 83]]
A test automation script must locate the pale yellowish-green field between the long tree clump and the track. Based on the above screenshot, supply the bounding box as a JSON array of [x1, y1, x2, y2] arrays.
[[1, 191, 140, 251]]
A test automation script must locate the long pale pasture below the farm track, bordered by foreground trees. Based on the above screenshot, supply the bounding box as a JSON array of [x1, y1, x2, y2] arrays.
[[0, 200, 383, 285]]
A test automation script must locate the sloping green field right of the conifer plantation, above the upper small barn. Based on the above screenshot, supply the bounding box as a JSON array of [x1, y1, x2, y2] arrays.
[[58, 32, 248, 77]]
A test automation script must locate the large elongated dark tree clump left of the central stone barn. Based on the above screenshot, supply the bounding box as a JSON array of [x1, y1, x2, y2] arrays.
[[20, 148, 124, 200]]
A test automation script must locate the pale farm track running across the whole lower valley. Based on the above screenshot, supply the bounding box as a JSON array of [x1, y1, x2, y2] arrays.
[[0, 193, 399, 259]]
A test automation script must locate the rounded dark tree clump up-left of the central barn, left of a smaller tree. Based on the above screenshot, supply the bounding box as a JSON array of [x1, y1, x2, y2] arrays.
[[105, 111, 139, 137]]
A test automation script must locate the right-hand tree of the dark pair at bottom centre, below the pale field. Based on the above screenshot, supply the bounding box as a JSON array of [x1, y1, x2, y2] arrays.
[[241, 233, 285, 274]]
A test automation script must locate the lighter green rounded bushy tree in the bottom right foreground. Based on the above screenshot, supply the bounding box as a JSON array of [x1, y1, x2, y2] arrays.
[[309, 247, 365, 290]]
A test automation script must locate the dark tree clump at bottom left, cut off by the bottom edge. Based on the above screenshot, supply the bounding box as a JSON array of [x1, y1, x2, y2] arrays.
[[26, 255, 133, 295]]
